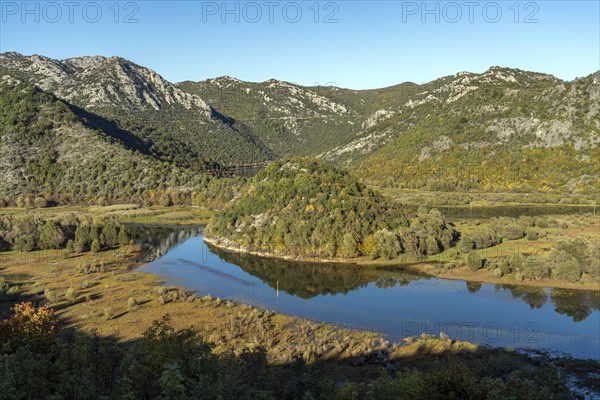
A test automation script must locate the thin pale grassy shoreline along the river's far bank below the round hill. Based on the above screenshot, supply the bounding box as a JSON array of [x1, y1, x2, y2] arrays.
[[202, 236, 600, 292]]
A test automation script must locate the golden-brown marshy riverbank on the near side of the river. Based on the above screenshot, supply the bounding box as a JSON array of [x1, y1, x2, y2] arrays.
[[0, 241, 600, 391]]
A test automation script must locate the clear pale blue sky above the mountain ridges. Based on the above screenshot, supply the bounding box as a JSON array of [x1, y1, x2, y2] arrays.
[[0, 0, 600, 89]]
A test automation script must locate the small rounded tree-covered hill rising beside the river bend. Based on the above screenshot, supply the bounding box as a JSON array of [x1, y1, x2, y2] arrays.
[[207, 159, 456, 258]]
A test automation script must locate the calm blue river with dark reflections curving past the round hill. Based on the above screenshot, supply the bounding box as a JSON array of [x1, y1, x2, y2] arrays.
[[137, 227, 600, 359]]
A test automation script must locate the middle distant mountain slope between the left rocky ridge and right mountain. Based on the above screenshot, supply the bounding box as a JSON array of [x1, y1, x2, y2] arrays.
[[177, 77, 363, 157]]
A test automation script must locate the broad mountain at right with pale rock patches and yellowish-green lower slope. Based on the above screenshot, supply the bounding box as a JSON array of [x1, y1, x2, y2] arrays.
[[340, 68, 600, 191]]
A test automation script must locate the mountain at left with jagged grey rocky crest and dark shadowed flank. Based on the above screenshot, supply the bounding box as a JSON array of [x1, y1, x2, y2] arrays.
[[0, 53, 272, 166]]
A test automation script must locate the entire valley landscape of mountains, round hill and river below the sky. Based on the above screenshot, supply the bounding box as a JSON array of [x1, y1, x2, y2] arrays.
[[0, 52, 600, 400]]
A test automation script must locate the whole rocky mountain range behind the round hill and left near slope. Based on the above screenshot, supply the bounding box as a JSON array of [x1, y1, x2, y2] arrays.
[[0, 53, 600, 192]]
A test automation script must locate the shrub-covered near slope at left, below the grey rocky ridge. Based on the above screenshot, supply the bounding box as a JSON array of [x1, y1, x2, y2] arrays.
[[0, 75, 212, 203]]
